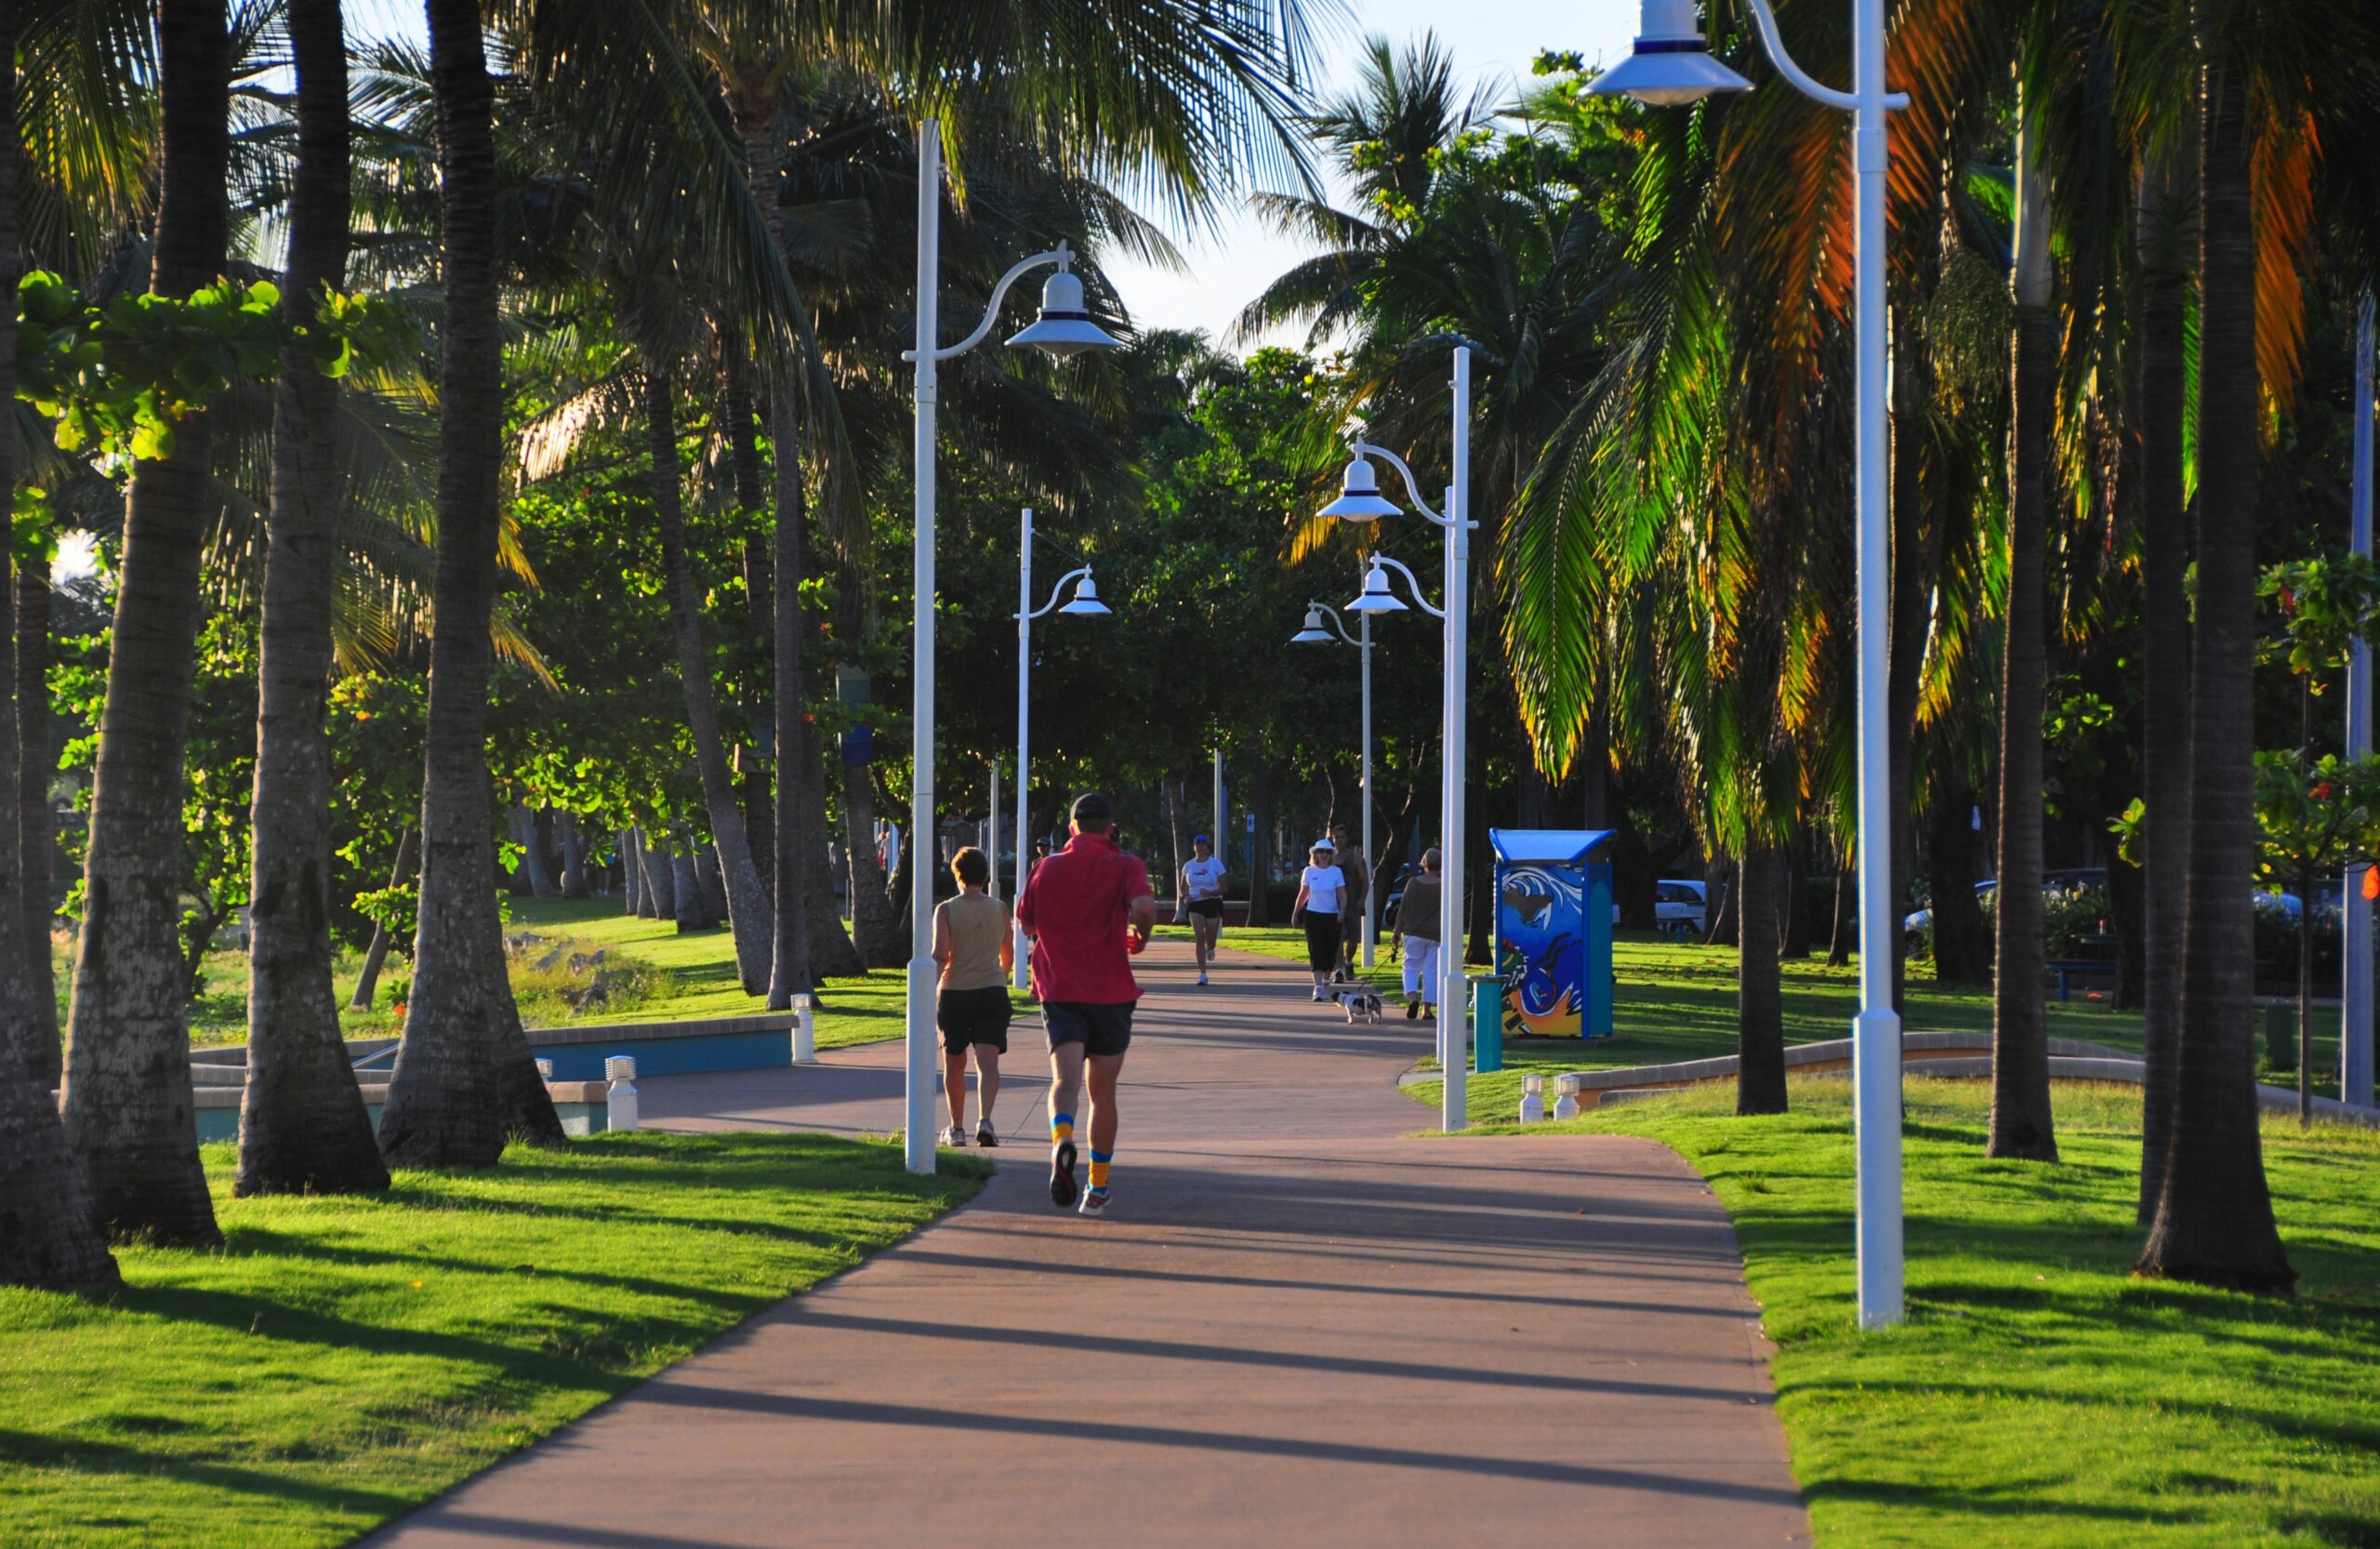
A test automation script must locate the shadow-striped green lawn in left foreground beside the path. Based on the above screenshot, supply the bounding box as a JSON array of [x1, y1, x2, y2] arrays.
[[0, 1132, 987, 1549]]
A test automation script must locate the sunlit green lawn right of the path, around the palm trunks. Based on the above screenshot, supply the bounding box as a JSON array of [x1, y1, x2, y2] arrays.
[[1457, 1078, 2380, 1549]]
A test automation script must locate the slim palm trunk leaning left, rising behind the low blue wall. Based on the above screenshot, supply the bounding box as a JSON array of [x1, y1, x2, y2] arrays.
[[645, 359, 776, 995]]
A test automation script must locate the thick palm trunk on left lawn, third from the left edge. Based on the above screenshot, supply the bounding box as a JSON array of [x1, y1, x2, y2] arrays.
[[233, 0, 388, 1195]]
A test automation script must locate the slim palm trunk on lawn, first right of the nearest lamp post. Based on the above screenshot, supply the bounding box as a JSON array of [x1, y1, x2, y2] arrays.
[[1982, 131, 2058, 1161]]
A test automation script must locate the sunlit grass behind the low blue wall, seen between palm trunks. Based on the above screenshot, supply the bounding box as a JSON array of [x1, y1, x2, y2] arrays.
[[170, 899, 946, 1050]]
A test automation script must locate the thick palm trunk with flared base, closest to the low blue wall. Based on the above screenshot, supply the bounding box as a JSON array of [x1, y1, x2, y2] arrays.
[[381, 0, 526, 1169]]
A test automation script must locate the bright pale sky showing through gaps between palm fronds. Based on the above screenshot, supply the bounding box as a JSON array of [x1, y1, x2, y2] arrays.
[[348, 0, 1637, 340]]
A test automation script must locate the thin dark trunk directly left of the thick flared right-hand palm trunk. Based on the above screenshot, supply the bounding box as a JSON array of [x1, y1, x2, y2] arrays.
[[2135, 124, 2189, 1225]]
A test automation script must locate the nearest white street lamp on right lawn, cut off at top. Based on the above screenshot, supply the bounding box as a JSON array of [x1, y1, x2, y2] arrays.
[[1590, 0, 1909, 1328]]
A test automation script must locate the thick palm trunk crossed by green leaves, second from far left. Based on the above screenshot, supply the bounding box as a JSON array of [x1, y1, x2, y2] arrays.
[[57, 0, 231, 1247]]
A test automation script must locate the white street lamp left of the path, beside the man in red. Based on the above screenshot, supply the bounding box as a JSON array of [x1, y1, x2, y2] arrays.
[[902, 119, 1117, 1173]]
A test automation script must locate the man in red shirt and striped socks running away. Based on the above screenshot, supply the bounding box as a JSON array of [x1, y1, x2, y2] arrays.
[[1016, 790, 1157, 1216]]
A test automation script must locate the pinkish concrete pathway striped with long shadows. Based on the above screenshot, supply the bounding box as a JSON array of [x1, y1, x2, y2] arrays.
[[366, 945, 1809, 1549]]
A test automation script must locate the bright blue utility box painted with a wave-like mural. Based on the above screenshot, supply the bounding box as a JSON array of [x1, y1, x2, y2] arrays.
[[1488, 828, 1619, 1038]]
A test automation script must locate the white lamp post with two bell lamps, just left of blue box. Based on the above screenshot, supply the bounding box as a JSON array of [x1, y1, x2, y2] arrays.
[[1321, 345, 1471, 1132]]
